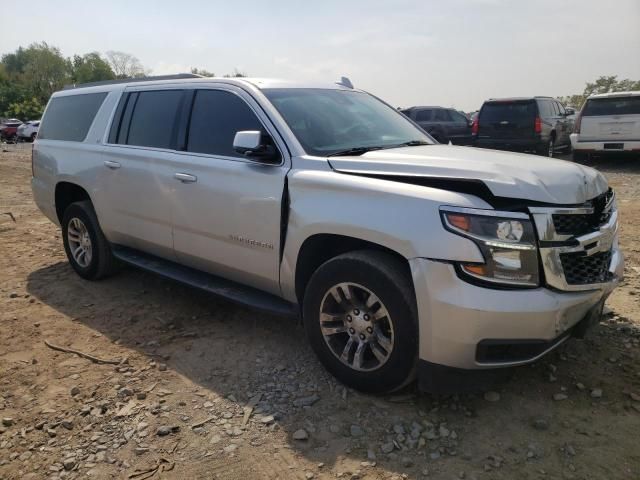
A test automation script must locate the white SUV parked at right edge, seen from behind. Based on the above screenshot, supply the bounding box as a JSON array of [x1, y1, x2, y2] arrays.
[[571, 91, 640, 160]]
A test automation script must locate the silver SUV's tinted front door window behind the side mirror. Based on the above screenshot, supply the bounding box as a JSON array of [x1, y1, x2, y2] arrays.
[[187, 90, 263, 157]]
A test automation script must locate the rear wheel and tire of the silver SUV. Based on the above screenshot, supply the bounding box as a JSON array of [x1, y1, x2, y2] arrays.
[[62, 200, 117, 280]]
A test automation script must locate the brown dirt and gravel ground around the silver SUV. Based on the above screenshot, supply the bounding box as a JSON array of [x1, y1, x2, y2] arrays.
[[0, 146, 640, 480]]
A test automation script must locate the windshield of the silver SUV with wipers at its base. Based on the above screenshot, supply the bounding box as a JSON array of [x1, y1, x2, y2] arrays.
[[264, 88, 433, 157]]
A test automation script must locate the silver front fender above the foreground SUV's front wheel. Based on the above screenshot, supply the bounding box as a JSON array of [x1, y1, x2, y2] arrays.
[[280, 170, 491, 301]]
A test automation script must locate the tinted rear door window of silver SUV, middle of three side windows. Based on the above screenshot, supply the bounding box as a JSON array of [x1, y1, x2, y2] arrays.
[[126, 90, 182, 148]]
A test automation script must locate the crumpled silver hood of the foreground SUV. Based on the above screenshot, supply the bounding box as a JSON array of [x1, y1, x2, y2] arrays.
[[329, 145, 607, 204]]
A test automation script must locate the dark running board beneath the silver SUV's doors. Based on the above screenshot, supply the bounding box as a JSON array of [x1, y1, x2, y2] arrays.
[[112, 245, 298, 317]]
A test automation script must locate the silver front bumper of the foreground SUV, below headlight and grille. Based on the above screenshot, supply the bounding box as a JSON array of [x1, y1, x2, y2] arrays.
[[410, 255, 623, 376]]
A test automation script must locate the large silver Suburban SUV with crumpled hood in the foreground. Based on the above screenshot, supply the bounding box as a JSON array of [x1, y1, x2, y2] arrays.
[[32, 78, 623, 392]]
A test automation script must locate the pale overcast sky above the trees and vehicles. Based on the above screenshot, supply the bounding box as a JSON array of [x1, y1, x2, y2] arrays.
[[0, 0, 640, 110]]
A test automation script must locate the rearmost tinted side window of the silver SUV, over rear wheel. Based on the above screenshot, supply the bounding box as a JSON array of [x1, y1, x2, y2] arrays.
[[38, 92, 107, 142]]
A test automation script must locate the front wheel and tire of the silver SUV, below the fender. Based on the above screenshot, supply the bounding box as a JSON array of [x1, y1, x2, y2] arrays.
[[303, 250, 418, 393]]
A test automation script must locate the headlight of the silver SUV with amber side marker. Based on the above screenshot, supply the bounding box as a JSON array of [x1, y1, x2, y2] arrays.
[[440, 207, 540, 287]]
